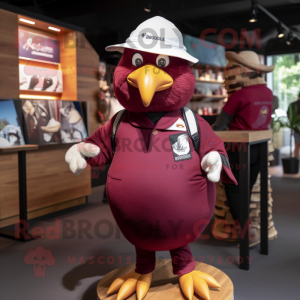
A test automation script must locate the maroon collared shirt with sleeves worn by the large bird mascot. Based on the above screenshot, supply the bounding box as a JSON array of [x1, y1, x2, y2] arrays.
[[85, 109, 236, 251]]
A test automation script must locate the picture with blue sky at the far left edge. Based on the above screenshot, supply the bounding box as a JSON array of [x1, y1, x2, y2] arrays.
[[0, 100, 25, 147]]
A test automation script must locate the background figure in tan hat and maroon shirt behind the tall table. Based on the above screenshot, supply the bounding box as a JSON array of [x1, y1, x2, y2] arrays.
[[212, 51, 277, 246]]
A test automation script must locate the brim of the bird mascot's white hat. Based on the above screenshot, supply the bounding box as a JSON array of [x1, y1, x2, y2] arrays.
[[105, 43, 198, 65]]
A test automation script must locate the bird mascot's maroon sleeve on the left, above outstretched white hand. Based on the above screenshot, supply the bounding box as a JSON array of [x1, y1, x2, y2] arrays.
[[84, 115, 116, 167]]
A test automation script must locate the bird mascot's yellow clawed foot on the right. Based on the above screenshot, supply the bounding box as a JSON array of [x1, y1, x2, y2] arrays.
[[179, 270, 221, 300]]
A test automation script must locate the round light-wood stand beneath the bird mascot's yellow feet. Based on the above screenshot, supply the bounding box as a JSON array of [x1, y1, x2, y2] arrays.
[[97, 259, 233, 300]]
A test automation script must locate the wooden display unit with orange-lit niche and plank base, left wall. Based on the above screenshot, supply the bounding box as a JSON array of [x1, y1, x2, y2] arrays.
[[0, 9, 99, 228]]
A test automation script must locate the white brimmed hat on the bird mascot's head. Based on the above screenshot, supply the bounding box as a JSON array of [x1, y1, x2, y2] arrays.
[[105, 17, 198, 65]]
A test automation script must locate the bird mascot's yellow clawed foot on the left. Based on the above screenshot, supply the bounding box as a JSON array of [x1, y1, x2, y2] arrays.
[[107, 271, 152, 300]]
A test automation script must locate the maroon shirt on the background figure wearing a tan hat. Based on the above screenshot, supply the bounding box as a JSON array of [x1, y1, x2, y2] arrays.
[[223, 84, 273, 130]]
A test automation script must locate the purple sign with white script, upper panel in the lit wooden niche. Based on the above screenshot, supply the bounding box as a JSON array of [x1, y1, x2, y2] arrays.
[[18, 28, 60, 63]]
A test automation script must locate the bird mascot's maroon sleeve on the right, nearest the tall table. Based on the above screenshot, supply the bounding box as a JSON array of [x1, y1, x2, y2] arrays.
[[197, 115, 237, 185]]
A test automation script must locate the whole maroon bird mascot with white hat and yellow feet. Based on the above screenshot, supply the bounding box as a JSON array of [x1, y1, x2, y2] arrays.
[[66, 17, 236, 300]]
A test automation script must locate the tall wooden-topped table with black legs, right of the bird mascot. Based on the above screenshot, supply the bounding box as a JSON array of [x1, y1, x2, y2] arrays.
[[215, 130, 272, 270]]
